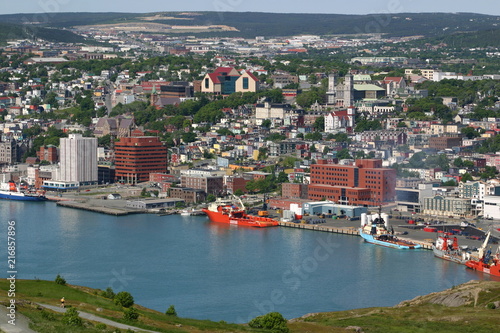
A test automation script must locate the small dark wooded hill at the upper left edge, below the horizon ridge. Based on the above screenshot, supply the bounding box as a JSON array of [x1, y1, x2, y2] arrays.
[[0, 19, 86, 44]]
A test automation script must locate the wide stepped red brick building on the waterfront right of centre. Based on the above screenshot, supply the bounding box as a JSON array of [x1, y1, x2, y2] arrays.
[[309, 159, 396, 206]]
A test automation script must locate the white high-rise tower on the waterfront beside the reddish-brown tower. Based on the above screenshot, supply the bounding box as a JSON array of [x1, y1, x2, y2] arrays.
[[58, 134, 98, 185]]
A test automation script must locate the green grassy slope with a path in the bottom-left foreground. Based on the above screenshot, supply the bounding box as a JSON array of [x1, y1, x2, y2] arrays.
[[0, 280, 263, 333]]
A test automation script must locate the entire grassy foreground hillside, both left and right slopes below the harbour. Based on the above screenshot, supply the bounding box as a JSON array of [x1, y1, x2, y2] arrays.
[[0, 279, 500, 333]]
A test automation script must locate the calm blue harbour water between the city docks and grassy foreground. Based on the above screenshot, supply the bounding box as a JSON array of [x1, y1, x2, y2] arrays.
[[0, 201, 489, 323]]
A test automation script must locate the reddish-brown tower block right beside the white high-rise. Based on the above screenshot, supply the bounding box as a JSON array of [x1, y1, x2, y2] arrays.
[[115, 136, 167, 183]]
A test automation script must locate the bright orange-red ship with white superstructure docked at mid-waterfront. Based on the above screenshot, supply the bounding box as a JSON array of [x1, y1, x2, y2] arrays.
[[202, 196, 279, 228]]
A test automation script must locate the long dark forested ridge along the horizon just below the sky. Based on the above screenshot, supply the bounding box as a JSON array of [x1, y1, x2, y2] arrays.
[[0, 12, 500, 37]]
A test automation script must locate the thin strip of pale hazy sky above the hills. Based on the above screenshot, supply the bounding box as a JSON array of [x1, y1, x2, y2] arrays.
[[0, 0, 500, 15]]
